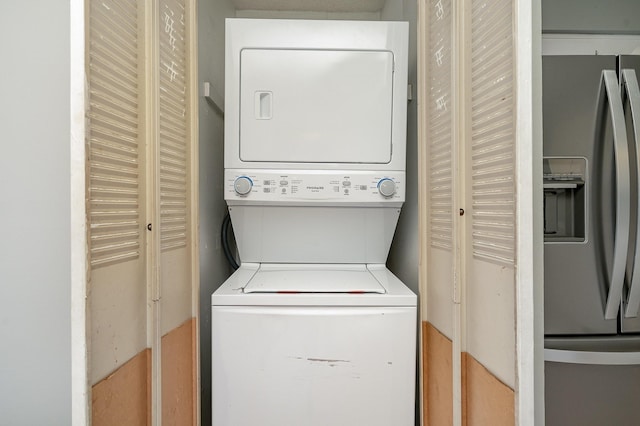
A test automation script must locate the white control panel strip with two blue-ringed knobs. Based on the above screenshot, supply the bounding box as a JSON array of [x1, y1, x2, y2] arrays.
[[225, 169, 405, 203]]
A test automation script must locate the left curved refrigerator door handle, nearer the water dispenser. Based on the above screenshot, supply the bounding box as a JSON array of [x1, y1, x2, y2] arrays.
[[596, 70, 631, 319]]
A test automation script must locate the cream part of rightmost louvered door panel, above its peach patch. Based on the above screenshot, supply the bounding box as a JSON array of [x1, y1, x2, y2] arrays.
[[465, 0, 516, 392]]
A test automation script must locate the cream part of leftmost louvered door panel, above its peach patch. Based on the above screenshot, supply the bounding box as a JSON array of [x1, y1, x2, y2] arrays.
[[87, 0, 147, 388]]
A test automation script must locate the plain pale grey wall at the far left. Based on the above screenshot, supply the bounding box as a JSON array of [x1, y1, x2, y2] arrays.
[[0, 0, 71, 425]]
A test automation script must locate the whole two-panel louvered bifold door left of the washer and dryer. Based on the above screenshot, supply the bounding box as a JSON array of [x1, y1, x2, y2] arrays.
[[87, 0, 197, 424]]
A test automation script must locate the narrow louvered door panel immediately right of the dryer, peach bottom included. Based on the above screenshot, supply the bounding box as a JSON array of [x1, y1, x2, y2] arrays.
[[421, 0, 457, 425]]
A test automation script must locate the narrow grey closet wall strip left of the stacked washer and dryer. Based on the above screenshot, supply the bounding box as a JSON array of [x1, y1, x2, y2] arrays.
[[198, 0, 235, 425]]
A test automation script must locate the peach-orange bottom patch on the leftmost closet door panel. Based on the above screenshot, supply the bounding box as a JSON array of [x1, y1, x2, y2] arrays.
[[91, 349, 151, 426]]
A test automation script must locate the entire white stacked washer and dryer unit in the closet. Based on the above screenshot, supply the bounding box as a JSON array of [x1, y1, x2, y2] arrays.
[[212, 19, 417, 426]]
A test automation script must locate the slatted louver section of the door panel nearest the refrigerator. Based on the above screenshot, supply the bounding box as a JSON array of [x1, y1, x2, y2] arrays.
[[471, 0, 515, 266]]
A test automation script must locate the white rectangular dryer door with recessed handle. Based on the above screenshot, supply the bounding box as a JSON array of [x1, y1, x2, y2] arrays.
[[240, 49, 394, 164]]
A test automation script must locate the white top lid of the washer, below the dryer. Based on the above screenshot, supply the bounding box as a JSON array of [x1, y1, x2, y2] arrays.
[[243, 264, 386, 294]]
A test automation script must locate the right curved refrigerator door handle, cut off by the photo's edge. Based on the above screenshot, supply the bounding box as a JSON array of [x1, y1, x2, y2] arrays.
[[620, 69, 640, 318]]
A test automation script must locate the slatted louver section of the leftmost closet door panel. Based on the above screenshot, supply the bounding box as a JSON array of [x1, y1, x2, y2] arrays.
[[87, 0, 141, 268]]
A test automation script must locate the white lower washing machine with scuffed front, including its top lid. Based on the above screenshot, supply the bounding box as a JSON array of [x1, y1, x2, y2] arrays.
[[211, 264, 416, 426]]
